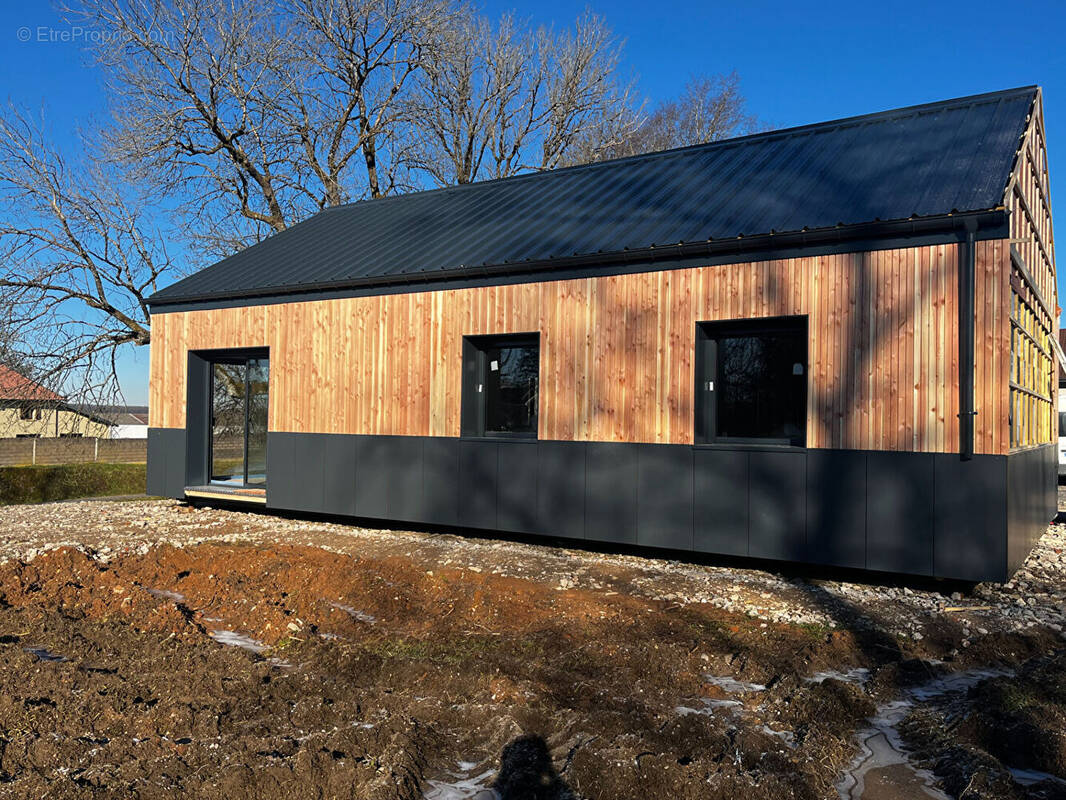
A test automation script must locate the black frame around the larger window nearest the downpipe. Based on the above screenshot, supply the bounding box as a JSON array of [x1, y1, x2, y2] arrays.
[[693, 315, 810, 449]]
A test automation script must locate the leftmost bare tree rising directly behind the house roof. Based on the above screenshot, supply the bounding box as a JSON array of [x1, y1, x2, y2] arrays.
[[77, 0, 298, 252]]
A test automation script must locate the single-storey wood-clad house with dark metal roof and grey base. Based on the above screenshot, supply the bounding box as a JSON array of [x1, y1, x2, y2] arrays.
[[148, 86, 1057, 580]]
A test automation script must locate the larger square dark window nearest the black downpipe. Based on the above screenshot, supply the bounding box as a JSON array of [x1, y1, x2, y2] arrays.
[[696, 317, 807, 447]]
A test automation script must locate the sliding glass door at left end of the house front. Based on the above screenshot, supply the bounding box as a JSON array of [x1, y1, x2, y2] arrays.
[[210, 357, 270, 486]]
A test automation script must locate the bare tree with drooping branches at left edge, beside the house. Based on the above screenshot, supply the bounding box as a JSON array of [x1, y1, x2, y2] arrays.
[[0, 108, 172, 403]]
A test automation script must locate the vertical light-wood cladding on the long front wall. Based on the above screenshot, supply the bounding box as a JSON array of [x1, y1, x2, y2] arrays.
[[149, 241, 1010, 453]]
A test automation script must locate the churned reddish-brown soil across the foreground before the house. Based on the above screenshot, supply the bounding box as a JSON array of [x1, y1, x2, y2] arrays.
[[0, 503, 1059, 800]]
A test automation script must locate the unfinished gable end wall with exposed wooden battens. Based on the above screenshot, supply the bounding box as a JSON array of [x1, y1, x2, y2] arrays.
[[1006, 94, 1059, 447]]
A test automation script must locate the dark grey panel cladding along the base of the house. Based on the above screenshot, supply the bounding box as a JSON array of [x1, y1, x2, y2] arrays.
[[148, 429, 1056, 580]]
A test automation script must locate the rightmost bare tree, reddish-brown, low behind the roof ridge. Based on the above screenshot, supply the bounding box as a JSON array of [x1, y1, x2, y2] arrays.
[[568, 73, 760, 163]]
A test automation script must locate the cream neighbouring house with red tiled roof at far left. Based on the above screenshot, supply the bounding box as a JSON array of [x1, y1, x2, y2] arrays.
[[0, 366, 111, 438]]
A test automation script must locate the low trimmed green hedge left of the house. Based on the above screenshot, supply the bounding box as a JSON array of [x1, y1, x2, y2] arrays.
[[0, 463, 146, 506]]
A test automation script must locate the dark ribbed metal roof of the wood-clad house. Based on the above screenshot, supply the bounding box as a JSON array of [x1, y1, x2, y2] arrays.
[[149, 86, 1038, 306]]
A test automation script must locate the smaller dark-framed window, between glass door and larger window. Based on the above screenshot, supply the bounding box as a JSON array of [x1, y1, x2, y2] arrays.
[[463, 334, 540, 438]]
